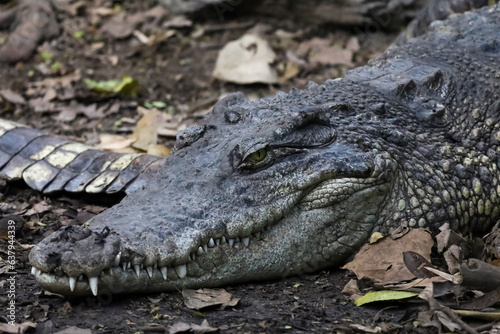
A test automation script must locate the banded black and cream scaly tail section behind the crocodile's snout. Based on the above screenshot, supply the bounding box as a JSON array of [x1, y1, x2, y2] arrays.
[[0, 119, 165, 194]]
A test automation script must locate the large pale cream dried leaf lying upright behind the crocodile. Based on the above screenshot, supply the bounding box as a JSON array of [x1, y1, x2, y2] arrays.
[[212, 34, 278, 84]]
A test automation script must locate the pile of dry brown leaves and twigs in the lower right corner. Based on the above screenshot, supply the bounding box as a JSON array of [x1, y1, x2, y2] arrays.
[[343, 224, 500, 333]]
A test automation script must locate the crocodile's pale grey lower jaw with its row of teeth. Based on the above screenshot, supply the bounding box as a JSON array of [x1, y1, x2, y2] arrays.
[[30, 179, 390, 296]]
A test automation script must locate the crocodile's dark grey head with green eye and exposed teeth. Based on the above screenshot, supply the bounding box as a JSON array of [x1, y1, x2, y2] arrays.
[[29, 81, 396, 295]]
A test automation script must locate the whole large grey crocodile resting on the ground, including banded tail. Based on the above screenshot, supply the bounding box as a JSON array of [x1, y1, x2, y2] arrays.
[[0, 2, 500, 296]]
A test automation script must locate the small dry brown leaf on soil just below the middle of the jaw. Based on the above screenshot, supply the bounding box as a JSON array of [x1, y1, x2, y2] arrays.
[[182, 289, 240, 310]]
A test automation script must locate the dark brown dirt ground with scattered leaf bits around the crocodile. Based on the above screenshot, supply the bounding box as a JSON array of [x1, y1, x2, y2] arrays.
[[0, 1, 440, 333]]
